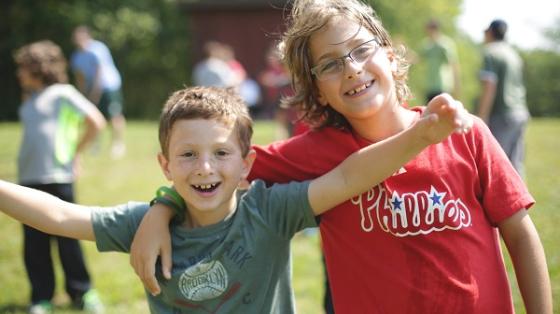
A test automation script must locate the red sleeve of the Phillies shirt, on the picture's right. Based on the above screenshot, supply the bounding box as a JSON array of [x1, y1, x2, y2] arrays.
[[472, 119, 535, 224]]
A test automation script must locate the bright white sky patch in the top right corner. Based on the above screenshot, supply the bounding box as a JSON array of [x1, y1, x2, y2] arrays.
[[459, 0, 560, 49]]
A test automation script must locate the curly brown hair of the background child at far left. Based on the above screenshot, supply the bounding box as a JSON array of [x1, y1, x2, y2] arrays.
[[14, 40, 68, 86]]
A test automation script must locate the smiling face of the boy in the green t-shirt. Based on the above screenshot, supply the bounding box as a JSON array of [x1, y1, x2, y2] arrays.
[[158, 119, 255, 227]]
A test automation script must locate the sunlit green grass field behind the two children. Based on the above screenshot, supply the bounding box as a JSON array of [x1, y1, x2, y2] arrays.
[[0, 119, 560, 313]]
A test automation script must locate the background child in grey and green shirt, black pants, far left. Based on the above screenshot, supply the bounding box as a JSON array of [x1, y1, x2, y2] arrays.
[[14, 41, 105, 314]]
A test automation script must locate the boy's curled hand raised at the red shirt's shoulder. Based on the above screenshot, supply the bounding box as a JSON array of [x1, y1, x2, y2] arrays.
[[422, 94, 473, 144]]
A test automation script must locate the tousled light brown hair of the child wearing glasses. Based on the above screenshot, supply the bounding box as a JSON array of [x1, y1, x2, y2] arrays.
[[279, 0, 410, 130]]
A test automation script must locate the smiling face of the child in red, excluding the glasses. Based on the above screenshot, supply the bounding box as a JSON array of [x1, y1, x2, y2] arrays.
[[310, 17, 397, 126]]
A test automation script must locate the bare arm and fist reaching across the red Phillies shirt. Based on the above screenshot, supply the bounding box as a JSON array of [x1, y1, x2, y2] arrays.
[[309, 95, 472, 215]]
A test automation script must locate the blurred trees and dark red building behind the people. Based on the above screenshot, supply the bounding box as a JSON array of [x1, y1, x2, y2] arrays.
[[0, 0, 560, 121]]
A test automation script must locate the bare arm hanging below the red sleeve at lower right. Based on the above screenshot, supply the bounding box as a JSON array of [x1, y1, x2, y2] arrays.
[[498, 209, 552, 314]]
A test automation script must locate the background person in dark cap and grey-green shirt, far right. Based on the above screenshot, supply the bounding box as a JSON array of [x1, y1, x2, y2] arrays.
[[478, 19, 530, 176]]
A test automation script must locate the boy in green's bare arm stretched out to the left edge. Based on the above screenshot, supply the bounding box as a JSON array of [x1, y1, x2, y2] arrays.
[[0, 180, 95, 241]]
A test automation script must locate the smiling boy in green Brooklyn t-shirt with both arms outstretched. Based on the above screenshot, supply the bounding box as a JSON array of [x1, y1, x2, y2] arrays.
[[0, 87, 471, 313]]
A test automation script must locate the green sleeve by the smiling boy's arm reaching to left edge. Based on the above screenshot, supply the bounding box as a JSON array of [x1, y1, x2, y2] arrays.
[[91, 202, 149, 252]]
